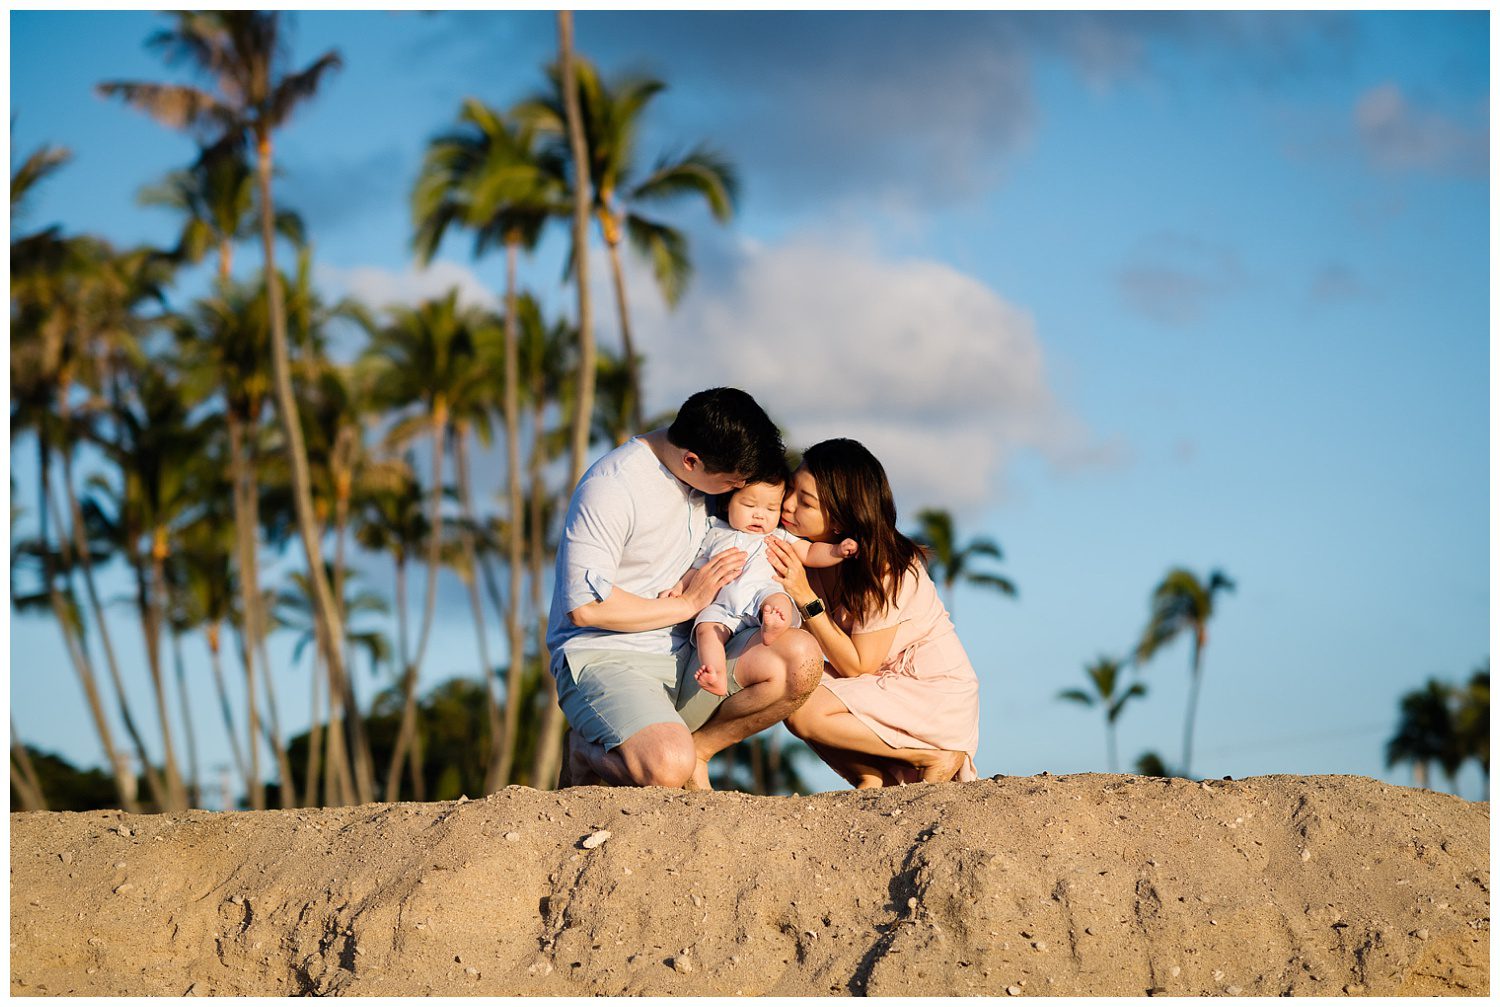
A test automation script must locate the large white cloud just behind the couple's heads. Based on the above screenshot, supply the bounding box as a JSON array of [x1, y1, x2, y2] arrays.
[[615, 231, 1113, 509]]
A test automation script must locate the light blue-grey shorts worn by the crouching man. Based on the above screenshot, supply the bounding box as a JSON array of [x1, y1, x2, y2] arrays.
[[557, 626, 759, 752]]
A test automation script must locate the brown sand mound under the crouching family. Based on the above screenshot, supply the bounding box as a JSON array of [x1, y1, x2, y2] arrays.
[[11, 774, 1490, 996]]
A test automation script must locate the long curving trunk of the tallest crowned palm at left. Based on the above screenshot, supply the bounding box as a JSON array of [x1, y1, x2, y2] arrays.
[[257, 132, 354, 798]]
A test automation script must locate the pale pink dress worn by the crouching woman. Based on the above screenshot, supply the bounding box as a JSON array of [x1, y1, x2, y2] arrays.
[[809, 560, 980, 780]]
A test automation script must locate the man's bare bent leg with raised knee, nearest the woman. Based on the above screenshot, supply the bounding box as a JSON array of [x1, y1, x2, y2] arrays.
[[692, 629, 824, 789]]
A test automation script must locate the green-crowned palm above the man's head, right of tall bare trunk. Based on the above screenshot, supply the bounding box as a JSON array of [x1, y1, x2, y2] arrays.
[[516, 59, 740, 429]]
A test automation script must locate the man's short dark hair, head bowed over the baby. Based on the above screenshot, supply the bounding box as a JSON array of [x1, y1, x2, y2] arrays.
[[666, 389, 786, 480]]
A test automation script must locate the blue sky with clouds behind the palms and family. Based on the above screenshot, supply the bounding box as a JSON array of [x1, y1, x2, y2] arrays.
[[11, 11, 1491, 798]]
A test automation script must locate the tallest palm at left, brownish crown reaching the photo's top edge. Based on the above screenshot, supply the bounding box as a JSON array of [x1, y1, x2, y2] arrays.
[[98, 11, 344, 780]]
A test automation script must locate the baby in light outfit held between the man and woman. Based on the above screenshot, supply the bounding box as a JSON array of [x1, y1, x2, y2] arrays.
[[671, 473, 860, 696]]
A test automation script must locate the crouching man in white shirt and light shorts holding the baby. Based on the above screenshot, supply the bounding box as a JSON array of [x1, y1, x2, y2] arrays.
[[548, 389, 824, 789]]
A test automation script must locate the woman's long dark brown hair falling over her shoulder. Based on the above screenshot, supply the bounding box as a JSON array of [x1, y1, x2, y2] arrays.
[[803, 437, 921, 621]]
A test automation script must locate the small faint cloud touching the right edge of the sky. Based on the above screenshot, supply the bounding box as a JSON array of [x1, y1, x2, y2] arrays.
[[1355, 84, 1490, 177]]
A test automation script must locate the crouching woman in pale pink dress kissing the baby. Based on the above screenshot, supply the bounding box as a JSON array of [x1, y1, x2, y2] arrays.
[[767, 438, 980, 789]]
